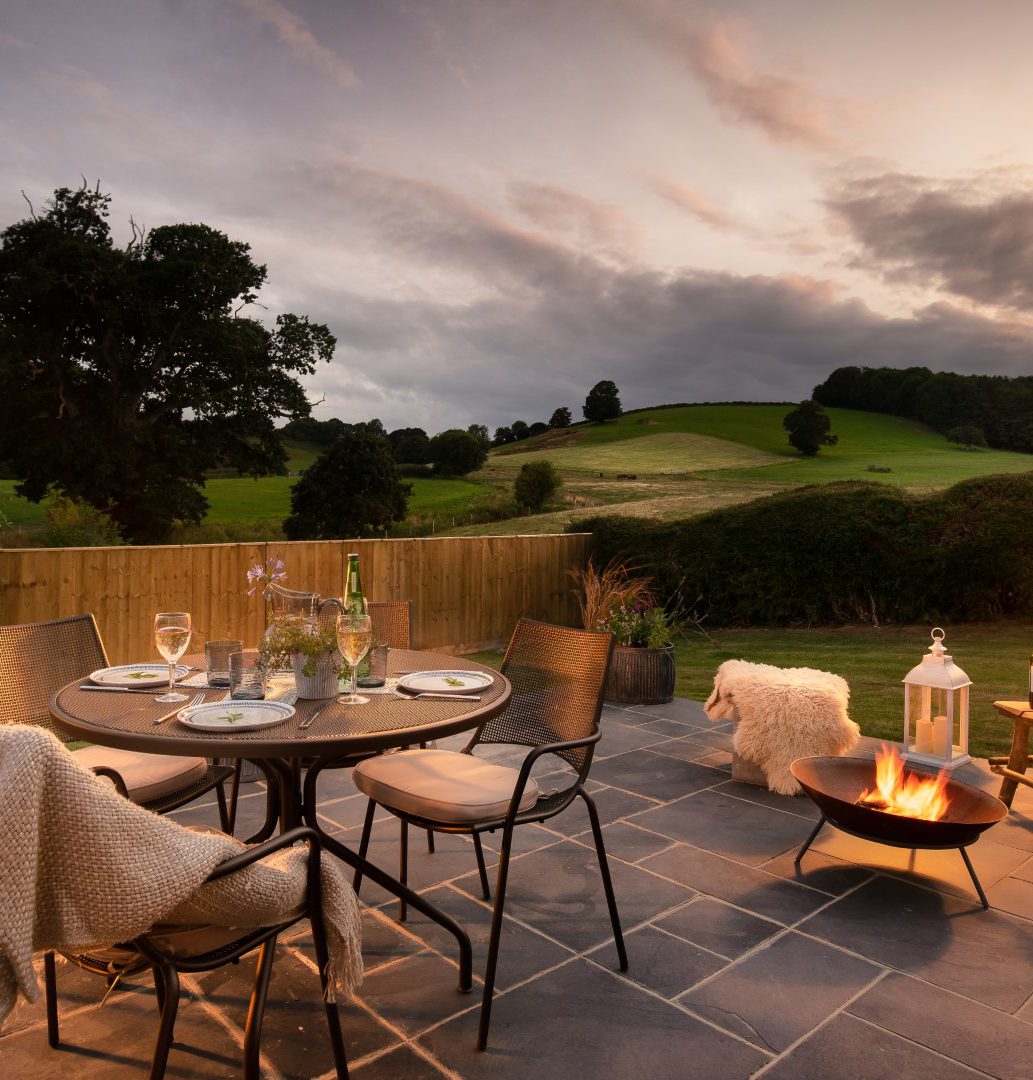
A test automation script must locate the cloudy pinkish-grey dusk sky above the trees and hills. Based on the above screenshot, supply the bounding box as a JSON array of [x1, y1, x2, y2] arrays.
[[6, 0, 1033, 434]]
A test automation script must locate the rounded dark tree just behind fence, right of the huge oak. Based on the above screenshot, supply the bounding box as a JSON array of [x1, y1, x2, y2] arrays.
[[283, 424, 412, 540]]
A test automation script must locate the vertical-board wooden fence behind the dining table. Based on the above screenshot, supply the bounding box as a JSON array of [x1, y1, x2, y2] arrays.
[[0, 534, 589, 663]]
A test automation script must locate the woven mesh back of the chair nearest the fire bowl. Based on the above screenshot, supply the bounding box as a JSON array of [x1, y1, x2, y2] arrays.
[[473, 619, 614, 779]]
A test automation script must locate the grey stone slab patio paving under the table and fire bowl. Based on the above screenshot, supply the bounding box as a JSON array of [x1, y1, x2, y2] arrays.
[[0, 700, 1033, 1080]]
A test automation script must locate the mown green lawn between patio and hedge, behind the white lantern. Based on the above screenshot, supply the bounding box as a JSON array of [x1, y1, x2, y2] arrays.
[[475, 623, 1033, 757]]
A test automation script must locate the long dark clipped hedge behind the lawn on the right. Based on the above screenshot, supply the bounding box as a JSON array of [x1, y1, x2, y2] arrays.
[[572, 473, 1033, 626]]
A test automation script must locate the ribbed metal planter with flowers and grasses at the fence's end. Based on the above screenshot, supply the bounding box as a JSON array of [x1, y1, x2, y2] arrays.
[[573, 559, 675, 705]]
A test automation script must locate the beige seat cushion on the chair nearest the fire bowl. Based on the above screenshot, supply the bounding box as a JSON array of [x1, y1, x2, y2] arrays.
[[352, 750, 538, 824]]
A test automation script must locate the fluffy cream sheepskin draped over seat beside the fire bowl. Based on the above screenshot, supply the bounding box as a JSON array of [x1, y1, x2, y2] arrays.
[[705, 660, 861, 795]]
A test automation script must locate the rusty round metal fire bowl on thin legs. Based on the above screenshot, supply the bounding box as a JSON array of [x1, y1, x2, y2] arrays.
[[790, 757, 1008, 907]]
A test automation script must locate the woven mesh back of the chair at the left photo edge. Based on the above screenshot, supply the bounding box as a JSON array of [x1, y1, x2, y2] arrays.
[[0, 615, 108, 742]]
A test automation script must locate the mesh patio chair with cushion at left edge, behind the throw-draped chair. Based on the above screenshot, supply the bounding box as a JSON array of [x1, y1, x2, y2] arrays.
[[0, 615, 232, 816]]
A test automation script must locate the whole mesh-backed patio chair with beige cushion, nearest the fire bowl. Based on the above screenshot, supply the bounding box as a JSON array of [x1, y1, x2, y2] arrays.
[[352, 619, 628, 1050]]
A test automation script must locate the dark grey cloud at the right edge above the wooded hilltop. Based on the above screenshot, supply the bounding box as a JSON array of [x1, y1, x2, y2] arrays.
[[827, 170, 1033, 312]]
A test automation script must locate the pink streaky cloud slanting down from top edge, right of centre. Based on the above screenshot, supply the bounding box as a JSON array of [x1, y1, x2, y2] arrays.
[[618, 0, 858, 150]]
